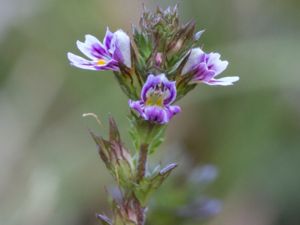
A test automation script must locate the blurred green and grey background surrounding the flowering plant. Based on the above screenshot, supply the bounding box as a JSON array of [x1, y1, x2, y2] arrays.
[[0, 0, 300, 225]]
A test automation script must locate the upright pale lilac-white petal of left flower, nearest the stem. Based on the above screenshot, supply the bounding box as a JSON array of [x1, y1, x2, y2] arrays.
[[112, 30, 131, 68]]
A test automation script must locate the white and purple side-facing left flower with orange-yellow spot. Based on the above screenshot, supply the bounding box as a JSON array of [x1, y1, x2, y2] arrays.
[[68, 28, 131, 71]]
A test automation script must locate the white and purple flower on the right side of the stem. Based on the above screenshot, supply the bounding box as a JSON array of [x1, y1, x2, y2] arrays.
[[182, 48, 239, 86]]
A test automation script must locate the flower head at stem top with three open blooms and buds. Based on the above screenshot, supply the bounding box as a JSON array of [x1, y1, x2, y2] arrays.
[[68, 8, 239, 124]]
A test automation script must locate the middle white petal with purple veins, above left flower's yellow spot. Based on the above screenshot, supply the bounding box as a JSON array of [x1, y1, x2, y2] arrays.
[[76, 34, 111, 60]]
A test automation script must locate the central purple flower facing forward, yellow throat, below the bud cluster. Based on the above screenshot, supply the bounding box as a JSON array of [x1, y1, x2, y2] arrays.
[[128, 74, 181, 124]]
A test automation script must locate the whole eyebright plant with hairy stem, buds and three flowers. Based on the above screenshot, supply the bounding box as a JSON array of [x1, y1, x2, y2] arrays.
[[68, 6, 239, 225]]
